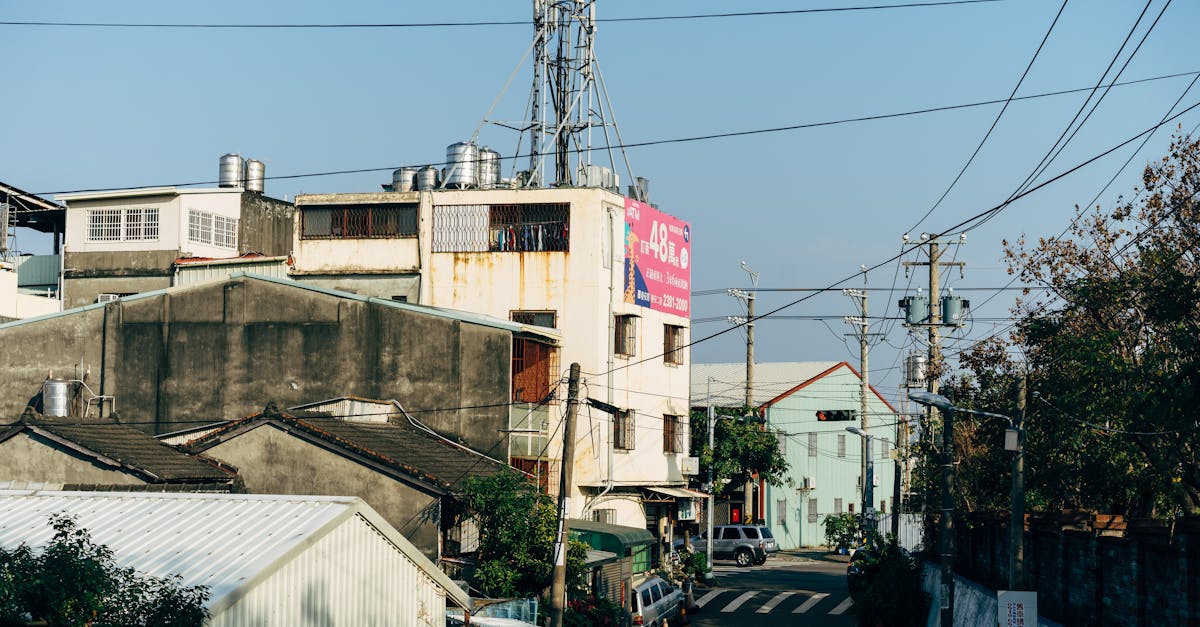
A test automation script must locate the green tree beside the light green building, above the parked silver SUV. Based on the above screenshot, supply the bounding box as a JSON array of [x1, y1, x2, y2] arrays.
[[691, 407, 792, 496]]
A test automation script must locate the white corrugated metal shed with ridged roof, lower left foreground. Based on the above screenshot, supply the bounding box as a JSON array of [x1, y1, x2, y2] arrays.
[[0, 490, 470, 627]]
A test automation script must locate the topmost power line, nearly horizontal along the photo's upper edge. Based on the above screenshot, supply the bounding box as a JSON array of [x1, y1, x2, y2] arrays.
[[0, 0, 1002, 30]]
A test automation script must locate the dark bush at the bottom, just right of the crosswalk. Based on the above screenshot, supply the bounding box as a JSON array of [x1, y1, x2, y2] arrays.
[[851, 536, 930, 627]]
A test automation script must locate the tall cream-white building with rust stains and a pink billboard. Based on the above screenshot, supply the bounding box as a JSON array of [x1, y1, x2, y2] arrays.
[[292, 187, 692, 530]]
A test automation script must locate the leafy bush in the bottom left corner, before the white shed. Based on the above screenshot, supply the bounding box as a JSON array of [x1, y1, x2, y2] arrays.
[[0, 514, 209, 627]]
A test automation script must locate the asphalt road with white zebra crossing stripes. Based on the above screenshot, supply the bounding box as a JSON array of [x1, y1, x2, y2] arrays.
[[688, 557, 856, 627]]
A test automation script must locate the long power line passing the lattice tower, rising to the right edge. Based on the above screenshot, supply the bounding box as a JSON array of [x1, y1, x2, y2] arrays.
[[30, 71, 1200, 196]]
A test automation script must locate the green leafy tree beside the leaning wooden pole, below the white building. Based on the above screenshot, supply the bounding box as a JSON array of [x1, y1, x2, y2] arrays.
[[462, 471, 587, 597]]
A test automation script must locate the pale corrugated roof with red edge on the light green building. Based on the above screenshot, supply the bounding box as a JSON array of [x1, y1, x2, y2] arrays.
[[691, 362, 841, 407]]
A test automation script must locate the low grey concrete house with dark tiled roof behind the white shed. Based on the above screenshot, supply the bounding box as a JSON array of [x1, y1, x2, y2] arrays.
[[182, 404, 508, 561]]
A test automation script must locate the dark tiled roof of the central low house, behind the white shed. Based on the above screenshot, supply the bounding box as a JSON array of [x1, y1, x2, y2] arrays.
[[187, 412, 509, 490]]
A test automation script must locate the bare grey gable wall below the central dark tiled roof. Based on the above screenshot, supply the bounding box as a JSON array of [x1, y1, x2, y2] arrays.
[[204, 424, 439, 561]]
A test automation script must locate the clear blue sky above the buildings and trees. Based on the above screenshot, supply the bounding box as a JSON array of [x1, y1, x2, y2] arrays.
[[0, 0, 1200, 399]]
